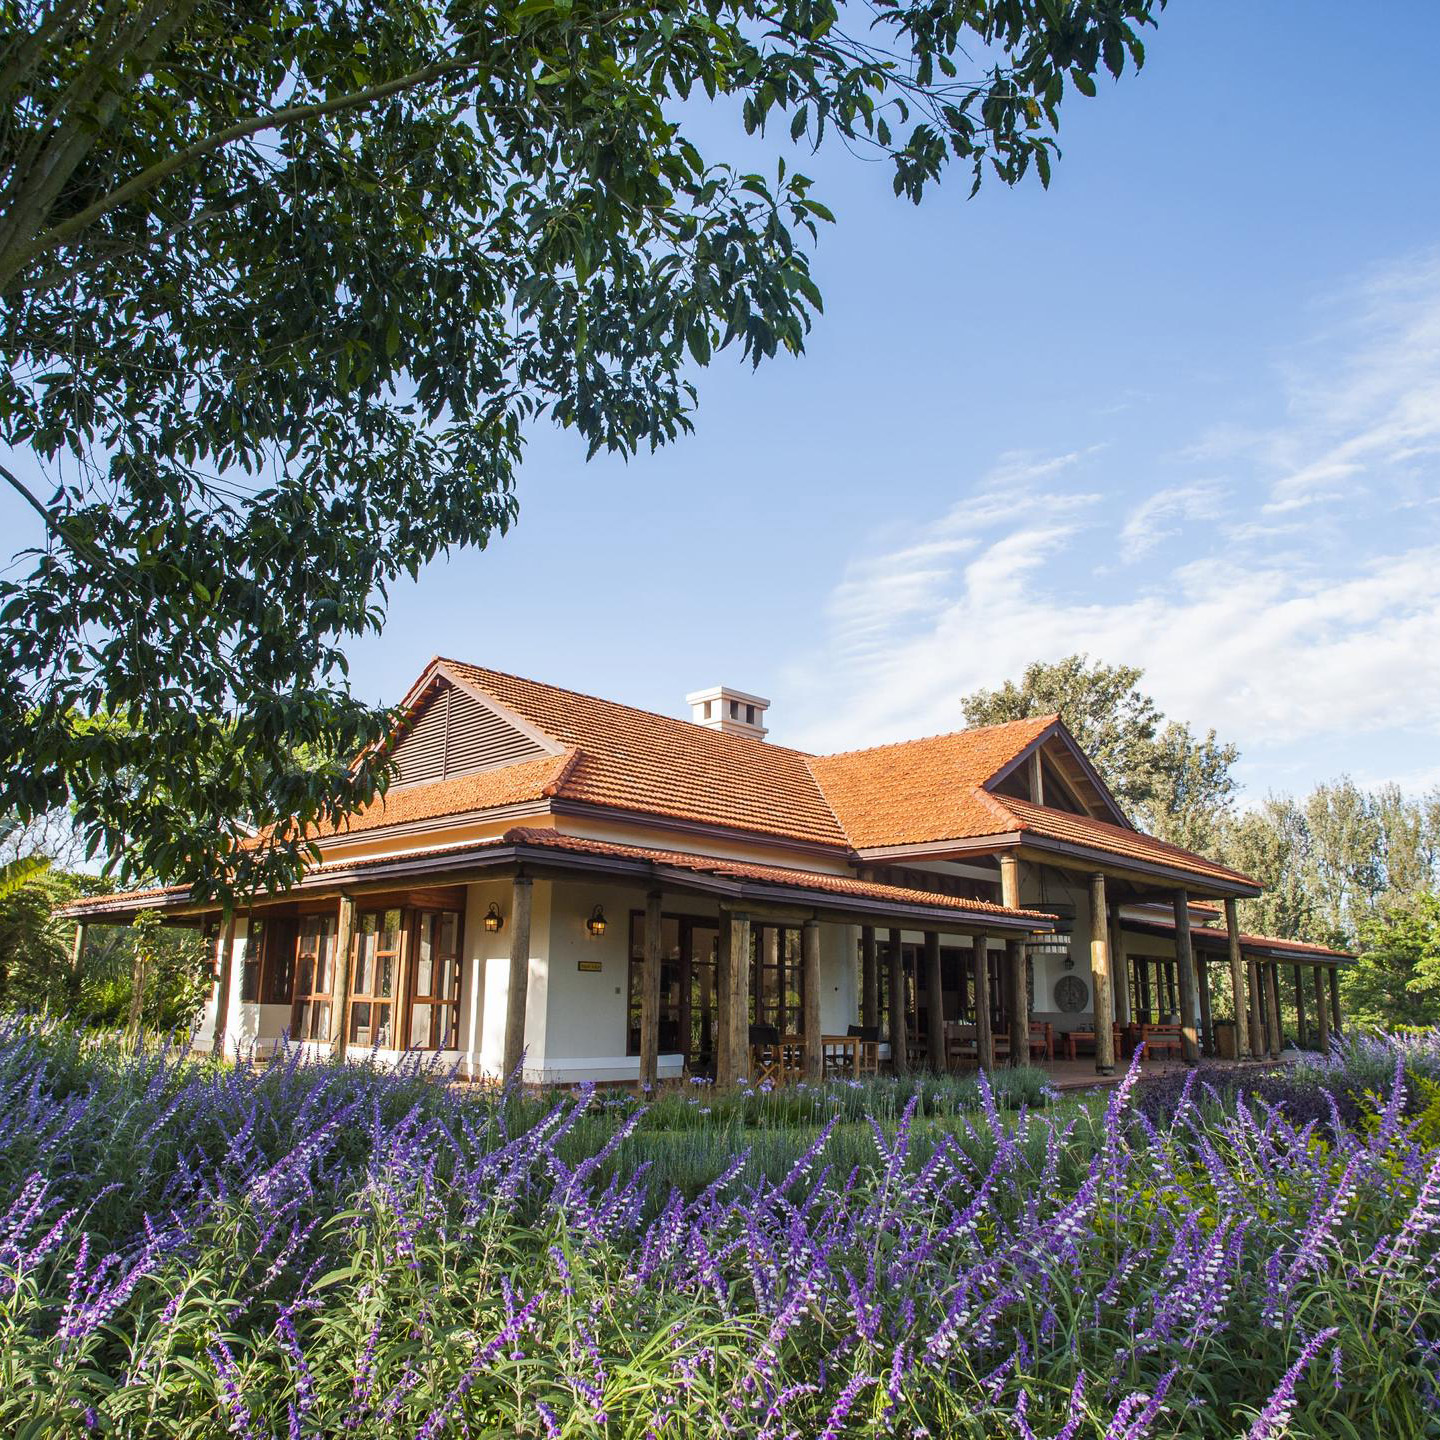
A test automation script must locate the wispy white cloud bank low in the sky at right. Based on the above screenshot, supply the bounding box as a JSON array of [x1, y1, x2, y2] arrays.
[[793, 250, 1440, 788]]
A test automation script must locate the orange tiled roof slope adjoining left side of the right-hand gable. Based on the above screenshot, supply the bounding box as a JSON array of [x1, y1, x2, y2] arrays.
[[809, 716, 1057, 850]]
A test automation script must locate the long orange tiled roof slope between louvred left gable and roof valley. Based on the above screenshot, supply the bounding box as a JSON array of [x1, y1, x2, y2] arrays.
[[445, 660, 845, 848]]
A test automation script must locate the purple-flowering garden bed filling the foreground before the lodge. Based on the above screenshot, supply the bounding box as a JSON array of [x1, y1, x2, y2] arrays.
[[0, 1024, 1440, 1440]]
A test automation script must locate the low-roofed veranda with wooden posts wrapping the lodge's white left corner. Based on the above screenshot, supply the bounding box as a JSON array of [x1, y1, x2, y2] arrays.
[[61, 828, 1051, 1086]]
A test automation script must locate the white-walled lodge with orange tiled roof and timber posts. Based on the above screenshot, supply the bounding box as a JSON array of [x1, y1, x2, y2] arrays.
[[65, 660, 1346, 1083]]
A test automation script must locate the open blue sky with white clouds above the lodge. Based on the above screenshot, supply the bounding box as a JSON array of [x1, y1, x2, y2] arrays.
[[3, 0, 1440, 795]]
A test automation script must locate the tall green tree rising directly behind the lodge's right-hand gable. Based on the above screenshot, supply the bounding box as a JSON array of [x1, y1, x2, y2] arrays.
[[960, 655, 1240, 850]]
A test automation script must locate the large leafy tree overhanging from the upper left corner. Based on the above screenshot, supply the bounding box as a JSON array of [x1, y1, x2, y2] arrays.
[[0, 0, 1164, 894]]
